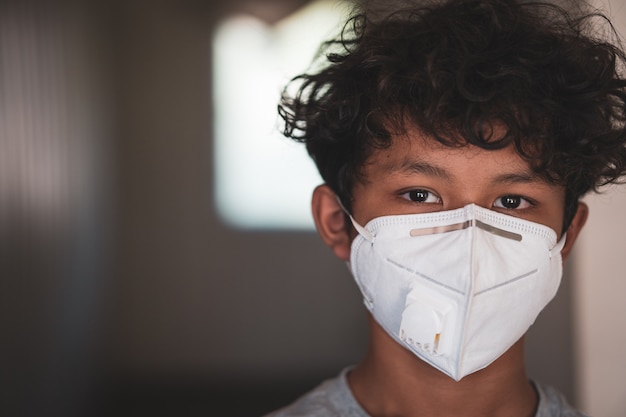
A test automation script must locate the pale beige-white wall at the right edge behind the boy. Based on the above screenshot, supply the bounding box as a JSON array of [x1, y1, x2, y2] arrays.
[[573, 0, 626, 417]]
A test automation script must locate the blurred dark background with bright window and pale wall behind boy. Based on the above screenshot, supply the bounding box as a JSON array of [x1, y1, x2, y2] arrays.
[[0, 0, 626, 417]]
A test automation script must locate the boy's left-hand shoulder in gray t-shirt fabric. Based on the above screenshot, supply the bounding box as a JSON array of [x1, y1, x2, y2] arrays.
[[265, 369, 369, 417]]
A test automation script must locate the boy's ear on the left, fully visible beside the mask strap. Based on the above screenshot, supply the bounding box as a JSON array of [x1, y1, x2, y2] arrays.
[[311, 184, 352, 261]]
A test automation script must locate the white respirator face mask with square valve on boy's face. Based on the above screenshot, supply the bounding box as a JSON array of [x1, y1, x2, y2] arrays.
[[350, 204, 565, 381]]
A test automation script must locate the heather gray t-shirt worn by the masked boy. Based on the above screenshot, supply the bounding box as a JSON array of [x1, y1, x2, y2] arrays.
[[265, 368, 587, 417]]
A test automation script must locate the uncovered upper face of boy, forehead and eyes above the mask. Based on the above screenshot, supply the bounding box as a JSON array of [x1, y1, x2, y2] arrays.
[[352, 130, 565, 237]]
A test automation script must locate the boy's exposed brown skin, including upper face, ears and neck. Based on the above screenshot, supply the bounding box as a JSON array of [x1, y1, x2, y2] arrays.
[[312, 129, 588, 417]]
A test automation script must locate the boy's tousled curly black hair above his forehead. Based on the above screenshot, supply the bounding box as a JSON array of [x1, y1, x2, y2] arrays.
[[278, 0, 626, 230]]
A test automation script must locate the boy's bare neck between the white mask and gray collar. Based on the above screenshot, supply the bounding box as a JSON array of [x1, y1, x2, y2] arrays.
[[348, 317, 537, 417]]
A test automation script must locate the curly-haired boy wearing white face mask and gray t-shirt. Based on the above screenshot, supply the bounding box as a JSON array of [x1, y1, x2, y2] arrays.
[[272, 0, 626, 417]]
